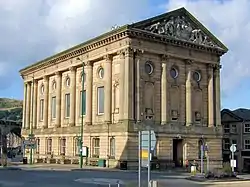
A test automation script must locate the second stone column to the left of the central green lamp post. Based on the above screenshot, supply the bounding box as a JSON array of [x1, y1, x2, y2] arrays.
[[56, 72, 62, 127]]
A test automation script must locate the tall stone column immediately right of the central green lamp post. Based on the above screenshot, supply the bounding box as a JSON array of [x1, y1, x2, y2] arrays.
[[86, 62, 93, 124]]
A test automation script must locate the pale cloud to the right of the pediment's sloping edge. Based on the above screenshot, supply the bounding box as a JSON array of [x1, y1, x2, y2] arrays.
[[165, 0, 250, 95]]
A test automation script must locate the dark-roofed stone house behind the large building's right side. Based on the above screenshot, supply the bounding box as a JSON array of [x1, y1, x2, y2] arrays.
[[221, 108, 250, 172]]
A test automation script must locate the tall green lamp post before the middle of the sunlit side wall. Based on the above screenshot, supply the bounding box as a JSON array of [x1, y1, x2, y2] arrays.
[[80, 62, 84, 168]]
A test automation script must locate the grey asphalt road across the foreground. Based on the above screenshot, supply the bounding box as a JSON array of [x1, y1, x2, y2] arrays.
[[0, 169, 203, 187]]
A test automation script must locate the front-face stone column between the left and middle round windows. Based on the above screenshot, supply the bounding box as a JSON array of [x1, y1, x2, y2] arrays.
[[161, 55, 168, 125]]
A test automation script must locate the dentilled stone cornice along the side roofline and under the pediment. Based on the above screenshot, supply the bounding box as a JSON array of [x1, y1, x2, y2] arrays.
[[20, 25, 226, 76]]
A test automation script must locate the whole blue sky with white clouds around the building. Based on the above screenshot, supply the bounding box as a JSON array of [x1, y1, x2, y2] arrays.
[[0, 0, 250, 109]]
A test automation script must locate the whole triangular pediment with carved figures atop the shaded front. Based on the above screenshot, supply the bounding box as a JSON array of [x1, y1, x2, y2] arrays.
[[131, 8, 228, 52]]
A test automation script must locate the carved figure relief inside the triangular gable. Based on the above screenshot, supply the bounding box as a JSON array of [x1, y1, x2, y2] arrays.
[[145, 16, 218, 47]]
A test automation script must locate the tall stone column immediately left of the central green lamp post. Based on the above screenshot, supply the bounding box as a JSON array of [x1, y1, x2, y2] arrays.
[[69, 67, 76, 126]]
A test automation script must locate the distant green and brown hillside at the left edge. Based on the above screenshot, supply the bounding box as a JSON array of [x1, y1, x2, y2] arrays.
[[0, 98, 23, 120]]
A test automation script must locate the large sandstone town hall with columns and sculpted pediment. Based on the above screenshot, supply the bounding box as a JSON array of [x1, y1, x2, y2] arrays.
[[20, 8, 227, 167]]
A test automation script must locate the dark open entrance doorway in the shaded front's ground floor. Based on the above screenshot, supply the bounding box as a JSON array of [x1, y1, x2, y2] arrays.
[[173, 139, 183, 167]]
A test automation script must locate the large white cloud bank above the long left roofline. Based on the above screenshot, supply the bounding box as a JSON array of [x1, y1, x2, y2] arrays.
[[0, 0, 152, 94]]
